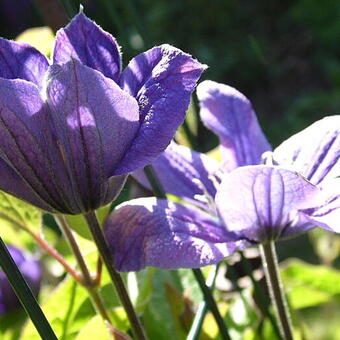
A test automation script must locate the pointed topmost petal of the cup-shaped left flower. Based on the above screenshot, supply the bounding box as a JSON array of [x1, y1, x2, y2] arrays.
[[53, 13, 121, 81]]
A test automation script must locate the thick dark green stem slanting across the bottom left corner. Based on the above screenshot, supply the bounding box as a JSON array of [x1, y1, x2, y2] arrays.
[[0, 237, 58, 340]]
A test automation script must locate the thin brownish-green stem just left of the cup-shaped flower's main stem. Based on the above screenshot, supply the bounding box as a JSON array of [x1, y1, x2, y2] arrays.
[[57, 215, 112, 324]]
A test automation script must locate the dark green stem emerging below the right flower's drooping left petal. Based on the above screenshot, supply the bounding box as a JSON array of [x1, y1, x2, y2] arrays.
[[192, 268, 231, 340]]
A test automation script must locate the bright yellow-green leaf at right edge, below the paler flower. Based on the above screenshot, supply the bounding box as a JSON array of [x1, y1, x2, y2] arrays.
[[282, 259, 340, 309]]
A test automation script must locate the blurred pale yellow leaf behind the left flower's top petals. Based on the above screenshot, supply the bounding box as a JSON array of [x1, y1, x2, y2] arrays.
[[15, 26, 54, 57]]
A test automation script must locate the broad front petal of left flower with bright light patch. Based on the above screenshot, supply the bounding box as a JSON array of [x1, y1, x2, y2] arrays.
[[47, 59, 139, 211]]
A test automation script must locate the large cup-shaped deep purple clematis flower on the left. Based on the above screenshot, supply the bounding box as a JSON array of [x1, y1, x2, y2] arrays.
[[0, 13, 205, 214]]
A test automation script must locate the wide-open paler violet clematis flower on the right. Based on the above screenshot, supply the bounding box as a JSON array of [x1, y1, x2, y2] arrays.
[[105, 81, 340, 271]]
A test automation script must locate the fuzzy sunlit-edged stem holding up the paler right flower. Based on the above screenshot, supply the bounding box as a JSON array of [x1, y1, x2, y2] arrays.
[[260, 241, 294, 340]]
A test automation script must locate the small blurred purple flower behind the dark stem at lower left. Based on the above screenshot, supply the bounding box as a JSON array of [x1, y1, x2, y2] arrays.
[[0, 246, 42, 315]]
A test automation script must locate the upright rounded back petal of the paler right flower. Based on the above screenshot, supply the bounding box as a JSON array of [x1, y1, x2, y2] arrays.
[[197, 80, 271, 171]]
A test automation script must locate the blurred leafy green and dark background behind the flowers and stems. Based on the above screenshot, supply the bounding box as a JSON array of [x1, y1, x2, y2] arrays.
[[0, 0, 340, 340]]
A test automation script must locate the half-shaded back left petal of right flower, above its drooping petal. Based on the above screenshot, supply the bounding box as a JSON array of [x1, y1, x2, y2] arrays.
[[132, 142, 220, 200]]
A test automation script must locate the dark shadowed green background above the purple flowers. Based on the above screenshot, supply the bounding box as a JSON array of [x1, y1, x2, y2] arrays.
[[0, 0, 340, 151]]
